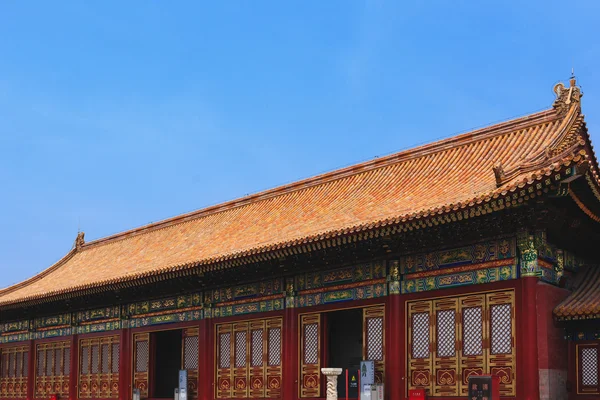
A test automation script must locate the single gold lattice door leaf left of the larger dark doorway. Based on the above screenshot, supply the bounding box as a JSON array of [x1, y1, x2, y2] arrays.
[[300, 314, 321, 397]]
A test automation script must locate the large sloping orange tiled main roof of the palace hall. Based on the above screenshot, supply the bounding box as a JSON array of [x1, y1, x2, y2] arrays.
[[0, 82, 597, 305]]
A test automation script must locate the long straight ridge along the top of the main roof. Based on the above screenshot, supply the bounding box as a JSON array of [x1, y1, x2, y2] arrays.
[[79, 108, 560, 250]]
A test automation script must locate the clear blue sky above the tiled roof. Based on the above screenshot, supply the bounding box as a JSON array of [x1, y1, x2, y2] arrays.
[[0, 0, 600, 287]]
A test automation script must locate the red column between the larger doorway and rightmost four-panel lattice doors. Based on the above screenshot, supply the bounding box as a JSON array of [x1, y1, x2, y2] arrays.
[[385, 294, 406, 400]]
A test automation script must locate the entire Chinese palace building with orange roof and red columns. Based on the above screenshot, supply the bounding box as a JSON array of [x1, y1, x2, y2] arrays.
[[0, 79, 600, 400]]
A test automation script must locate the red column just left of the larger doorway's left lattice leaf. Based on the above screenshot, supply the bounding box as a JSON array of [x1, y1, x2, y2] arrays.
[[282, 307, 298, 400]]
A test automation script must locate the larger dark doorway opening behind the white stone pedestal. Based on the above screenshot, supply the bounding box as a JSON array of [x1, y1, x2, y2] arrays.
[[326, 308, 363, 398]]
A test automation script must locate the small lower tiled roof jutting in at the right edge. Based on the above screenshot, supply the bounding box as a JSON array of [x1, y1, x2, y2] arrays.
[[554, 266, 600, 320]]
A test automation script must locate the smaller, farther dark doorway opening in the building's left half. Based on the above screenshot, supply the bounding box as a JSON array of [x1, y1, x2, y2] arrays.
[[151, 329, 182, 399]]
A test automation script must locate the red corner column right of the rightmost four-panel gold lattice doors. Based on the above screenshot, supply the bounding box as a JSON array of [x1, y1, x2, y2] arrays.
[[517, 277, 540, 400]]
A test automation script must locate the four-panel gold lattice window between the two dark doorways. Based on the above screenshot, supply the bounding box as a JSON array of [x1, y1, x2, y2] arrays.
[[215, 318, 282, 399]]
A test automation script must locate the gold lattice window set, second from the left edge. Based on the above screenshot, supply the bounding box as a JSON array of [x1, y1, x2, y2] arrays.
[[35, 341, 71, 397]]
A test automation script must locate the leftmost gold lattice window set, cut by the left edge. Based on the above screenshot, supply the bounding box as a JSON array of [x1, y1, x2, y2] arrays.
[[0, 346, 29, 399]]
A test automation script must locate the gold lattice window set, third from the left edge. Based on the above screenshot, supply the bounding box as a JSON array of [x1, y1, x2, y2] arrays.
[[78, 336, 120, 399]]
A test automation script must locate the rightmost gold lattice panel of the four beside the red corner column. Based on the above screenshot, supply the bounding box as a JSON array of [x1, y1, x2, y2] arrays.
[[486, 291, 516, 396]]
